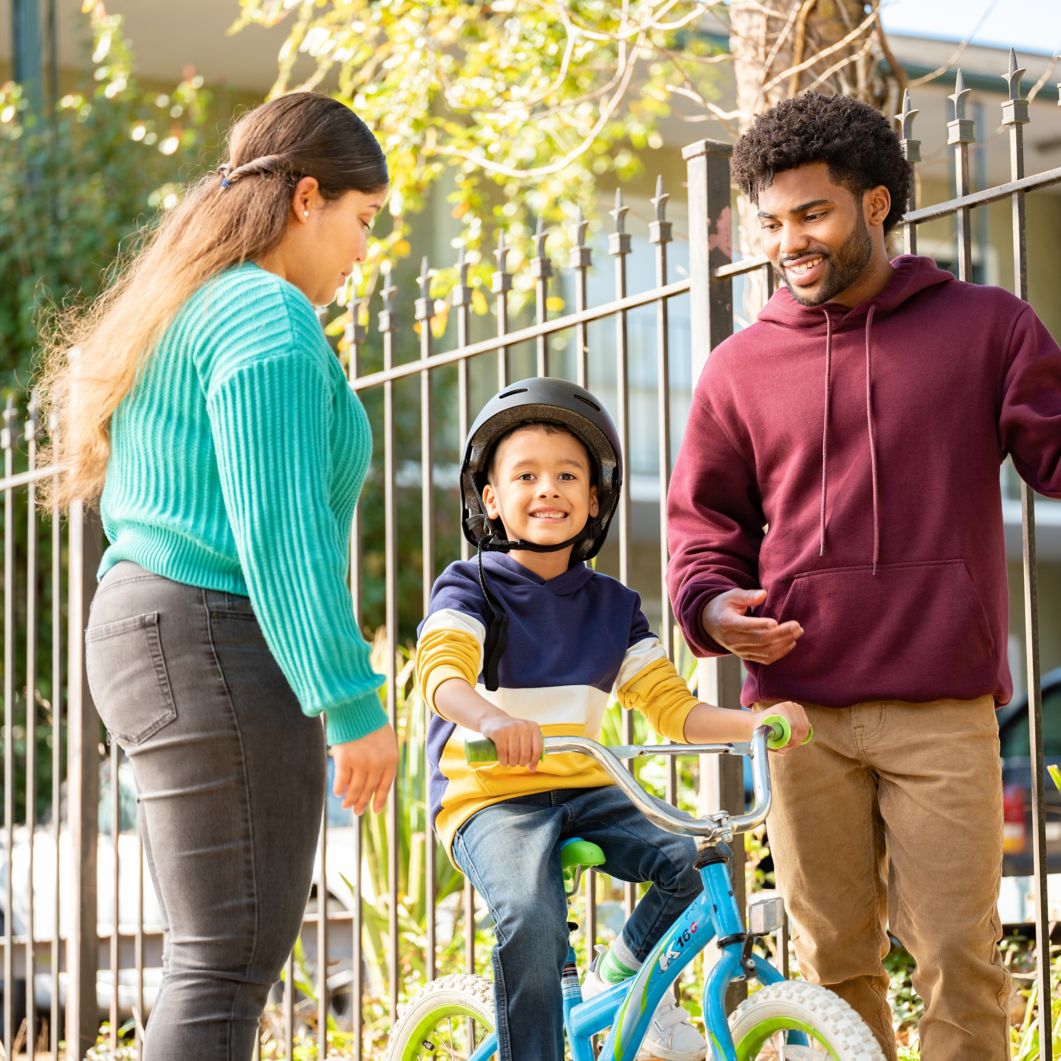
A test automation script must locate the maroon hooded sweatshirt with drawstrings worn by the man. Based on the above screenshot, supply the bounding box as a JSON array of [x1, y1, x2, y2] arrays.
[[667, 257, 1061, 706]]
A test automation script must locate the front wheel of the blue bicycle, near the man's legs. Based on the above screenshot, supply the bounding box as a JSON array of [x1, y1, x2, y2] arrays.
[[730, 980, 884, 1061]]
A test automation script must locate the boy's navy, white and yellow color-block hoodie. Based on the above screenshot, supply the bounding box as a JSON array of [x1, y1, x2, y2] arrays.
[[416, 553, 697, 851]]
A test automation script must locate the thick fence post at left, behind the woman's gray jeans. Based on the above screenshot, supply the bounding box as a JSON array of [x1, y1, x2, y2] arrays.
[[66, 502, 99, 1061]]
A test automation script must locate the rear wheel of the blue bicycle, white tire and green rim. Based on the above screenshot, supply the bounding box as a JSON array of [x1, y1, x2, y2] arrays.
[[387, 974, 495, 1061]]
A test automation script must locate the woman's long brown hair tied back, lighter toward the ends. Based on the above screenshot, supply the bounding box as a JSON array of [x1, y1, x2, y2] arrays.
[[37, 92, 388, 507]]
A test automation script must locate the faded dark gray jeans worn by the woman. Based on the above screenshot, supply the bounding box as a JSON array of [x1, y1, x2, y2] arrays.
[[86, 562, 325, 1061]]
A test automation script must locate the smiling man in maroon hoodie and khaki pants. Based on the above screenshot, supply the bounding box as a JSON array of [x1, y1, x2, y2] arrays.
[[667, 94, 1061, 1061]]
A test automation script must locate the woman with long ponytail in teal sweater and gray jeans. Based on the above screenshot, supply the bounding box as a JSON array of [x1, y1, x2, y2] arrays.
[[41, 92, 398, 1061]]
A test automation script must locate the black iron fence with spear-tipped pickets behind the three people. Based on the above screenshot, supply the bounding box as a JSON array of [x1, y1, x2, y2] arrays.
[[6, 51, 1061, 1058]]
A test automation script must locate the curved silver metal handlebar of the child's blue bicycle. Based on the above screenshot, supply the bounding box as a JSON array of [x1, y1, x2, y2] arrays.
[[465, 726, 778, 840]]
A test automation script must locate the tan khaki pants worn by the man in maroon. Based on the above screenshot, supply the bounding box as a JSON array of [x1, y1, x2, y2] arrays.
[[767, 697, 1010, 1061]]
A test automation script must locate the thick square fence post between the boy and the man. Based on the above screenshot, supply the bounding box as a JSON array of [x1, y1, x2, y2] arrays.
[[682, 140, 747, 1009]]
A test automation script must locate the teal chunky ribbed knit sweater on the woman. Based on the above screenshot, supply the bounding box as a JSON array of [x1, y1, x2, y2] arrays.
[[100, 263, 386, 744]]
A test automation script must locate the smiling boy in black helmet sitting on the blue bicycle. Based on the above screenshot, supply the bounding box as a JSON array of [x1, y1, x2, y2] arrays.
[[417, 379, 807, 1061]]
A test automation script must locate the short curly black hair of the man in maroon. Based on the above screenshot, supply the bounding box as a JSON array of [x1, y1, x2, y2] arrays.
[[733, 92, 910, 232]]
